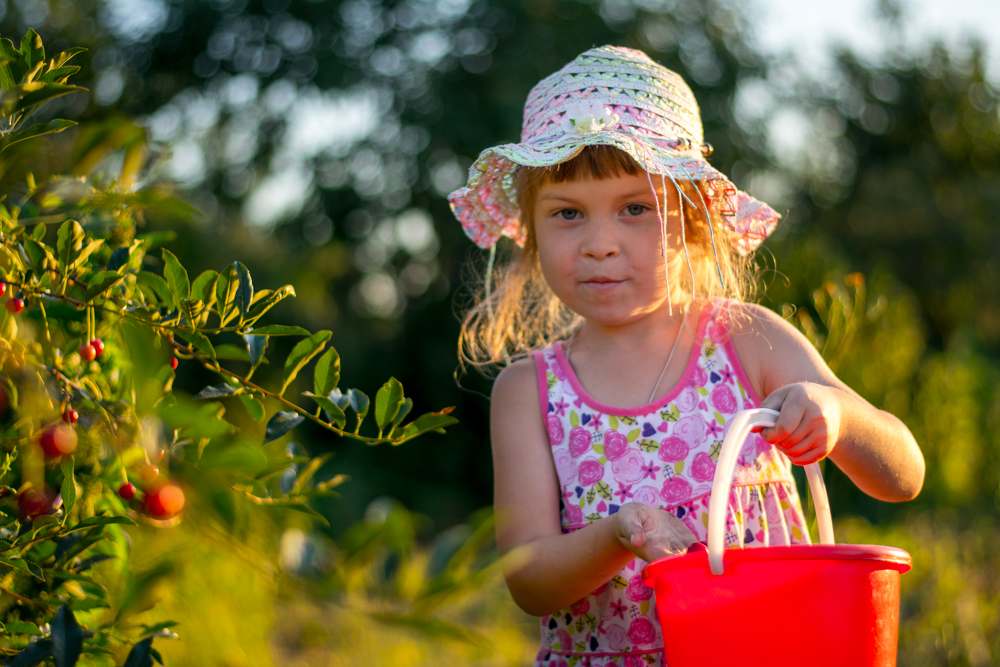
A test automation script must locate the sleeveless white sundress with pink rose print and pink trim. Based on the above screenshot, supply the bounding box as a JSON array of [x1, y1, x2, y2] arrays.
[[533, 299, 809, 667]]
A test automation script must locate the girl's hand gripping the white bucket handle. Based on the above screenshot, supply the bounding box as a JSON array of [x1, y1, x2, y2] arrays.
[[760, 382, 841, 465]]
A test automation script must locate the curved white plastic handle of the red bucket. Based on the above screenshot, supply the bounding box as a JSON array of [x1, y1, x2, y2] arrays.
[[708, 408, 834, 575]]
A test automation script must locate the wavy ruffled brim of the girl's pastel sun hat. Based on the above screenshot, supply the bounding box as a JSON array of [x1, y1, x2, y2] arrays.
[[448, 130, 780, 255]]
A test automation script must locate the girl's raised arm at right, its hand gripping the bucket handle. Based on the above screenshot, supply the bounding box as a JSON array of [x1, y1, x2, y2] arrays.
[[731, 305, 924, 502]]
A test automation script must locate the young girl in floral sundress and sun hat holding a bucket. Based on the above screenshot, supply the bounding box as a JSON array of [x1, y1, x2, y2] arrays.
[[450, 46, 924, 667]]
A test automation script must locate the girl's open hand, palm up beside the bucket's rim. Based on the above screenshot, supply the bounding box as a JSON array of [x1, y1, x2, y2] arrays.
[[614, 503, 698, 563]]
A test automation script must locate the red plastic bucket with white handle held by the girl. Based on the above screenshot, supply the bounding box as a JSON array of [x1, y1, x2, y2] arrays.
[[642, 408, 910, 667]]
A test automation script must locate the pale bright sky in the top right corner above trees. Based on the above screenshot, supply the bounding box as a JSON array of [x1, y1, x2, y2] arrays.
[[755, 0, 1000, 84]]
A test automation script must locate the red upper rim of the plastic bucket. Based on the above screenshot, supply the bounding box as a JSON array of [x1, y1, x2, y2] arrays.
[[641, 544, 913, 585]]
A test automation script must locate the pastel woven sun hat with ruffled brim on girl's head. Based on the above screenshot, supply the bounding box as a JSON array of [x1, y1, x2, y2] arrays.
[[448, 46, 779, 255]]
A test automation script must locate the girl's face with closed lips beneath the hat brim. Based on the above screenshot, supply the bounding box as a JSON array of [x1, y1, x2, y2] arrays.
[[533, 173, 679, 326]]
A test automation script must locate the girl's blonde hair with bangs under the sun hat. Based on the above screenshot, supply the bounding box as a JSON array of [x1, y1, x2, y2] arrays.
[[458, 146, 753, 372]]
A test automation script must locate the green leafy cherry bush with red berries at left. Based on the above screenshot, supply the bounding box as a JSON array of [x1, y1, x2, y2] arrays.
[[0, 31, 455, 667]]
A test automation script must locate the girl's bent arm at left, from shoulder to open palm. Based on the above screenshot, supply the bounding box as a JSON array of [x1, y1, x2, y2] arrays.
[[490, 359, 694, 616]]
